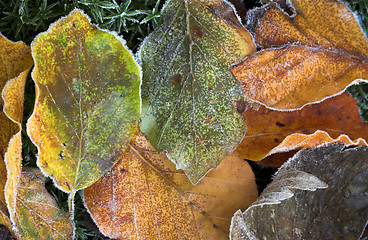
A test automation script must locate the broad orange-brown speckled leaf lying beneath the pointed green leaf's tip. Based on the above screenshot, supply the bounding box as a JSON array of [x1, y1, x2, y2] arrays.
[[84, 132, 258, 239]]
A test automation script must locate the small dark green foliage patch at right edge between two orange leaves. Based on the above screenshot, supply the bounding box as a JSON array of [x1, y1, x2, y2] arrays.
[[347, 82, 368, 122]]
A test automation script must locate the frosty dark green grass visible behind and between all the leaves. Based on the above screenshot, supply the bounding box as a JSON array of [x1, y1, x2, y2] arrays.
[[0, 0, 368, 240]]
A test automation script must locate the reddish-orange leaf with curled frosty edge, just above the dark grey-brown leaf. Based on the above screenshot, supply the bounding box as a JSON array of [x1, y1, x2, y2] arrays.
[[236, 93, 368, 167]]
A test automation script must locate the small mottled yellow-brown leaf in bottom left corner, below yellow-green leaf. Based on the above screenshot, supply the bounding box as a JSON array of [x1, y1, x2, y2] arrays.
[[13, 168, 74, 240]]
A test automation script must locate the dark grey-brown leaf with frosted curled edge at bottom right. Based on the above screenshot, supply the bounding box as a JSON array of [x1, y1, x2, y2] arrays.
[[230, 143, 368, 240]]
